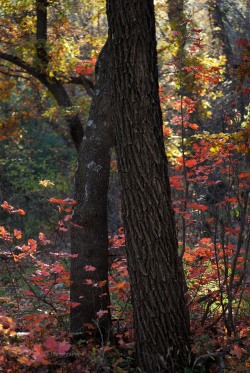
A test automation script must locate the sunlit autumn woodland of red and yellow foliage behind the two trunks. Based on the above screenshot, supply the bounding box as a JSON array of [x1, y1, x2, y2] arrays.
[[0, 0, 250, 372]]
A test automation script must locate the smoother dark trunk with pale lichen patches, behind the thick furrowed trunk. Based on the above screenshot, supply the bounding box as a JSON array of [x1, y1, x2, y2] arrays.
[[71, 43, 113, 342]]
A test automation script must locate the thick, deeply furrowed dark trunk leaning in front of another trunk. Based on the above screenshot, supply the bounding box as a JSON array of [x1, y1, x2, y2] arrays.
[[107, 0, 190, 373]]
